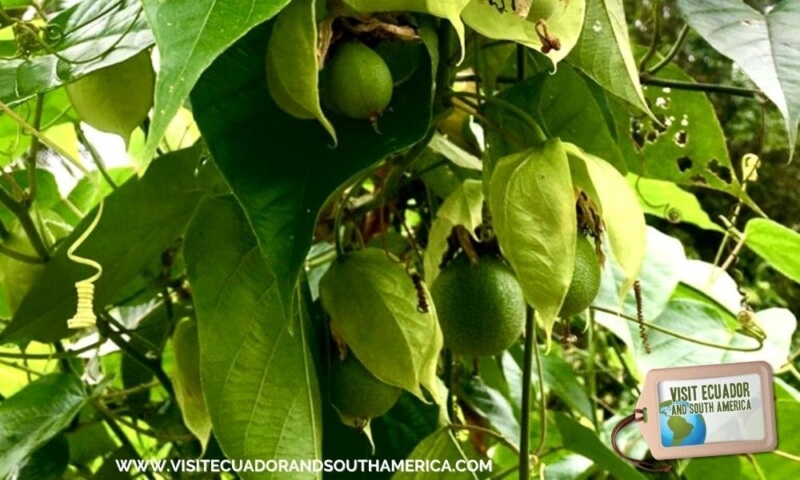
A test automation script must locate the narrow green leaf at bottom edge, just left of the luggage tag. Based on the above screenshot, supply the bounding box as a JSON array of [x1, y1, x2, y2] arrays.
[[556, 414, 647, 480]]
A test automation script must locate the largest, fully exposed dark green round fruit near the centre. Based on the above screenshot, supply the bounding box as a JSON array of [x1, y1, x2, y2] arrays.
[[431, 255, 526, 356]]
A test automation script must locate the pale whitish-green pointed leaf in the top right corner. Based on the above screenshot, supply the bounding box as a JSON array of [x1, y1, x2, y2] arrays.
[[678, 0, 800, 157]]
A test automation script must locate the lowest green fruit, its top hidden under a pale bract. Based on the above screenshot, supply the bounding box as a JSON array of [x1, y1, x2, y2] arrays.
[[331, 352, 402, 418]]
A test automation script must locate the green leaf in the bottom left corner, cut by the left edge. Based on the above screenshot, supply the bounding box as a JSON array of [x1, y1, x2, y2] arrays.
[[0, 373, 87, 478]]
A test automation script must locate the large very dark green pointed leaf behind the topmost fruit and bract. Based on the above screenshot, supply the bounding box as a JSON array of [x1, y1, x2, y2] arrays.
[[192, 22, 432, 328]]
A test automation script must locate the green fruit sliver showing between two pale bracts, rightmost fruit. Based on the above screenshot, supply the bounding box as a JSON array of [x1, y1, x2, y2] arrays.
[[558, 235, 600, 317]]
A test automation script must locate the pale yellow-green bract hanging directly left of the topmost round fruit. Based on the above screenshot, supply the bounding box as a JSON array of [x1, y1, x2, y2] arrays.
[[267, 0, 336, 143]]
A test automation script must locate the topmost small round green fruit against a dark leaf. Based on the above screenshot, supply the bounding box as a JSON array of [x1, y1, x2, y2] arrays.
[[324, 41, 394, 119]]
